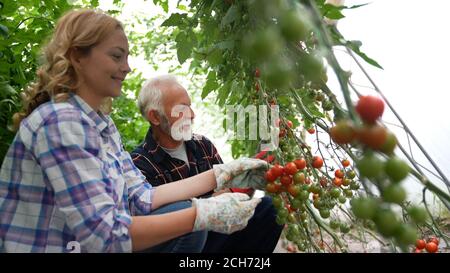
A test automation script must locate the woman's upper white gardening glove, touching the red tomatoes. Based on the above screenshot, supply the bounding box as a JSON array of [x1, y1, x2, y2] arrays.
[[213, 157, 269, 190]]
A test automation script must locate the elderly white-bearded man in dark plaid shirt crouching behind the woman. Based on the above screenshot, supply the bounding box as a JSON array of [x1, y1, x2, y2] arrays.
[[131, 75, 282, 253]]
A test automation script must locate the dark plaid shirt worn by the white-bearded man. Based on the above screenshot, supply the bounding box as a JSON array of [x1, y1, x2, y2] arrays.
[[131, 129, 223, 193]]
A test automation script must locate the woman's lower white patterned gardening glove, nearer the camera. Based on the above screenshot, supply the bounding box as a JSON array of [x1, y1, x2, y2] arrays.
[[192, 193, 261, 234]]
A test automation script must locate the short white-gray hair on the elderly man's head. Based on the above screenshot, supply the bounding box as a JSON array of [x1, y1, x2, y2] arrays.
[[138, 75, 179, 120]]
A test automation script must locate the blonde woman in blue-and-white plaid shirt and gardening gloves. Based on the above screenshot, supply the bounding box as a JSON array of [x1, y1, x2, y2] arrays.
[[0, 10, 267, 252]]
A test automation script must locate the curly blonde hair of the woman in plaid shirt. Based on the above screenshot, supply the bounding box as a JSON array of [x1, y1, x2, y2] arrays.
[[13, 9, 123, 130]]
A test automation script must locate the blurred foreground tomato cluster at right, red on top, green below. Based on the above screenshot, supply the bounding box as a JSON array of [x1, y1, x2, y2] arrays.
[[330, 96, 427, 246]]
